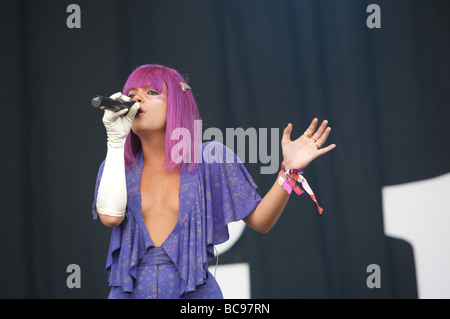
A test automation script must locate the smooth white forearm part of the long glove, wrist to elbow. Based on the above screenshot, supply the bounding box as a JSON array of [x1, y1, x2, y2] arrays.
[[97, 145, 127, 217]]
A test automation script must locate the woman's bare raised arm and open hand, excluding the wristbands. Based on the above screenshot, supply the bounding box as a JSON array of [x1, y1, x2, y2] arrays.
[[244, 118, 336, 233]]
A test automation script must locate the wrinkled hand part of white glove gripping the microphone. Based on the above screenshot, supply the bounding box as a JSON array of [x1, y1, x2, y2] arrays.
[[102, 92, 140, 148]]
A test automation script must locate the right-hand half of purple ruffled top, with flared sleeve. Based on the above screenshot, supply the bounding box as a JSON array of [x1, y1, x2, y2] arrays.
[[162, 142, 261, 294]]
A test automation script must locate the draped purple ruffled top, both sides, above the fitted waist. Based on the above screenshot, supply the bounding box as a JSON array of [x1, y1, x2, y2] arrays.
[[89, 142, 261, 294]]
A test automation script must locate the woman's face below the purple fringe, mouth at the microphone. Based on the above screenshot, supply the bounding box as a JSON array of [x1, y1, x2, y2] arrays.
[[128, 85, 167, 138]]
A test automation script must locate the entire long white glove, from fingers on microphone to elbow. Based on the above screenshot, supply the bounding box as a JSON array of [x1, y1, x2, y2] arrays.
[[97, 92, 140, 217]]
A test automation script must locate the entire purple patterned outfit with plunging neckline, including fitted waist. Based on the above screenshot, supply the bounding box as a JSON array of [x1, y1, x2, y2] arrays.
[[93, 142, 261, 299]]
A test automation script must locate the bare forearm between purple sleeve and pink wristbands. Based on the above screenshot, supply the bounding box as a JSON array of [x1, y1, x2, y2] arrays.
[[244, 171, 290, 233]]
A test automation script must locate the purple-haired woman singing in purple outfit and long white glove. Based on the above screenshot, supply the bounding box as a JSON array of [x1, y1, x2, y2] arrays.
[[93, 65, 335, 298]]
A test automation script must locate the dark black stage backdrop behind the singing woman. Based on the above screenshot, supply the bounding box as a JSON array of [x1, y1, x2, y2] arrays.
[[0, 0, 450, 298]]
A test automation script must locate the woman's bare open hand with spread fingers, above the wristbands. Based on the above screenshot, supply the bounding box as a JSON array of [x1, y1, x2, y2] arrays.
[[281, 118, 336, 169]]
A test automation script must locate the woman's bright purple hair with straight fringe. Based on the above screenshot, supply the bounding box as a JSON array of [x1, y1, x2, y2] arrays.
[[122, 64, 201, 171]]
